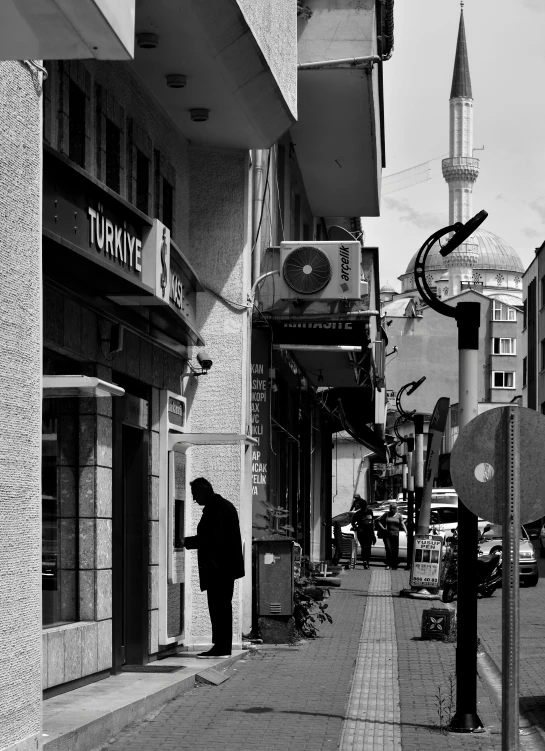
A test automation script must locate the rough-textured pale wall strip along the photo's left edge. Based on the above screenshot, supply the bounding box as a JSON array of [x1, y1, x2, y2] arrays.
[[0, 62, 42, 751]]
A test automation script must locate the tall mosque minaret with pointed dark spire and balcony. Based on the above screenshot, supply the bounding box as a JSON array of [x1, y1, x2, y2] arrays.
[[443, 6, 479, 297]]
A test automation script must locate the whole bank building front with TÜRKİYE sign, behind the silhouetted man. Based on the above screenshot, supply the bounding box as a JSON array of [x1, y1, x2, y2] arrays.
[[0, 0, 297, 751]]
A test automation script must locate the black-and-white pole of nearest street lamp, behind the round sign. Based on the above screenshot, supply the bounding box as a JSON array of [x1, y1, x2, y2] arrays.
[[450, 302, 482, 733]]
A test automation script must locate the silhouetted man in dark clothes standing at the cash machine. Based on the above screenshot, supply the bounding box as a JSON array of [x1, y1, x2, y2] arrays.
[[184, 477, 244, 658]]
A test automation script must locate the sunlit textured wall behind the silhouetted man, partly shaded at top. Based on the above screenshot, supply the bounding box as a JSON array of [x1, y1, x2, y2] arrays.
[[185, 147, 252, 644]]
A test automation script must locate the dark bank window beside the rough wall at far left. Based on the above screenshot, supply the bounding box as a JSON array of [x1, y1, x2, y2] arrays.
[[42, 399, 78, 628]]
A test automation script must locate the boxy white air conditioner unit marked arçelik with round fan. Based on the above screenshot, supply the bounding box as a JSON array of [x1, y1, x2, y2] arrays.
[[279, 240, 368, 300]]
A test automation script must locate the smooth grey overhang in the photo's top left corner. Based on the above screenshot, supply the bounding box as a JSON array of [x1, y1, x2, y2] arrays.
[[0, 0, 135, 60]]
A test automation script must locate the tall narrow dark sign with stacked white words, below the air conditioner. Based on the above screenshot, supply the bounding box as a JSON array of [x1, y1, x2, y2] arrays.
[[251, 329, 271, 537]]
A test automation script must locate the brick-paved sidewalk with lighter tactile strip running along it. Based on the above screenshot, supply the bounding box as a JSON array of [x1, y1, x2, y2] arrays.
[[93, 566, 501, 751]]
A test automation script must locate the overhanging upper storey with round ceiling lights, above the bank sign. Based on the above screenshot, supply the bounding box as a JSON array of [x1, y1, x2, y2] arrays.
[[131, 0, 297, 149]]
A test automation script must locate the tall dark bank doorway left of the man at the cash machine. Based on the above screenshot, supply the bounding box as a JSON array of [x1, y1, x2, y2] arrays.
[[113, 393, 149, 672]]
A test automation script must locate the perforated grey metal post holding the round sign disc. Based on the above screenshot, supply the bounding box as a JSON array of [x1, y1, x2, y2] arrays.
[[501, 406, 520, 751]]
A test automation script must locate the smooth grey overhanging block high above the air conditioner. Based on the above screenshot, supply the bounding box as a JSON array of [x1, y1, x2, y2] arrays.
[[291, 66, 382, 217]]
